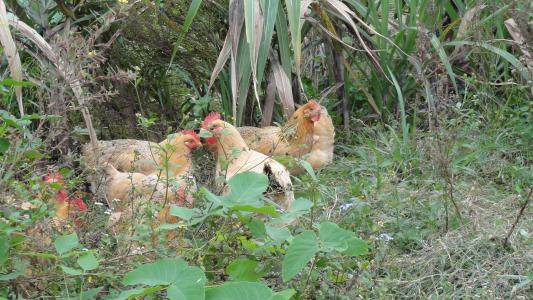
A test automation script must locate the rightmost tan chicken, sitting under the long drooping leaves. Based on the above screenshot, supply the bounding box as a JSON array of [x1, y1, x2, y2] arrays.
[[237, 100, 335, 175]]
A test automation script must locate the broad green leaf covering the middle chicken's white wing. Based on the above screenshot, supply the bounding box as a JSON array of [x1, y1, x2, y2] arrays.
[[224, 172, 268, 207]]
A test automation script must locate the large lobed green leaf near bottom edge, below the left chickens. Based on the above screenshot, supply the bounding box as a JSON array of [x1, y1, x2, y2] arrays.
[[122, 257, 206, 299]]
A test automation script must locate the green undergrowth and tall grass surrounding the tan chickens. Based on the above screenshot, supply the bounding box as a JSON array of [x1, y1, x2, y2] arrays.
[[0, 0, 533, 299]]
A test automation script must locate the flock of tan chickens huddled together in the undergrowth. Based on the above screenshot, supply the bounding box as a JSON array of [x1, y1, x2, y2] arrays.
[[64, 100, 335, 232]]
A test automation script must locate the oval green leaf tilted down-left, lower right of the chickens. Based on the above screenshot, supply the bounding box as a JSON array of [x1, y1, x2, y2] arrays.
[[281, 230, 318, 282]]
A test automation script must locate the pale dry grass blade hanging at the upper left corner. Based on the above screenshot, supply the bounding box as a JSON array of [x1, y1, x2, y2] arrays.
[[0, 0, 24, 117]]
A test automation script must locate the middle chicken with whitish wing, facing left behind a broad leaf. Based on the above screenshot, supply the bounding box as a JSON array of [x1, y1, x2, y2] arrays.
[[202, 113, 294, 209]]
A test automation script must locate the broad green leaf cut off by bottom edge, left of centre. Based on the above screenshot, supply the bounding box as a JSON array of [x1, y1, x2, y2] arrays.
[[205, 281, 272, 300]]
